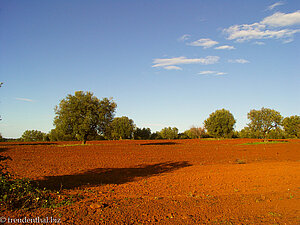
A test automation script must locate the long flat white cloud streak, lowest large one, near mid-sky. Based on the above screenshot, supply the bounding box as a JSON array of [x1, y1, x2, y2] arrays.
[[152, 56, 220, 69]]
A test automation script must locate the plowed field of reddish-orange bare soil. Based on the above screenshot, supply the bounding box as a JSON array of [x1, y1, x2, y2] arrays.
[[0, 139, 300, 225]]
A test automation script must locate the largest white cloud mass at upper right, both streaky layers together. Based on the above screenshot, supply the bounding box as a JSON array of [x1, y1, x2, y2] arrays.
[[223, 11, 300, 42]]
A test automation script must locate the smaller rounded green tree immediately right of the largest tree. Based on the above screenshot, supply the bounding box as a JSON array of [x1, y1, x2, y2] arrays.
[[109, 116, 135, 140]]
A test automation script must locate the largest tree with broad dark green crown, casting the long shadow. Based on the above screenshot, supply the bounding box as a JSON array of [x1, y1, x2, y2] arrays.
[[54, 91, 117, 144]]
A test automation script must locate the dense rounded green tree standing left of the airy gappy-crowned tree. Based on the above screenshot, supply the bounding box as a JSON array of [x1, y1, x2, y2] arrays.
[[204, 109, 236, 138]]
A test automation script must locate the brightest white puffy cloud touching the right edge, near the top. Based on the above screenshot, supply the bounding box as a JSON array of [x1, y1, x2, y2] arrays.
[[261, 10, 300, 27]]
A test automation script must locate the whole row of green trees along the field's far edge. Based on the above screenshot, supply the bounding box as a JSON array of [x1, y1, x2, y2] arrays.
[[7, 91, 300, 143]]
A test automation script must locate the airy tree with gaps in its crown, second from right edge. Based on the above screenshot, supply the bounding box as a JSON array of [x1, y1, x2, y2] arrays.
[[248, 107, 282, 140]]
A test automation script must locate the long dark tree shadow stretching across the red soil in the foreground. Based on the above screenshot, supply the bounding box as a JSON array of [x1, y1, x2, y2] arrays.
[[37, 161, 192, 190]]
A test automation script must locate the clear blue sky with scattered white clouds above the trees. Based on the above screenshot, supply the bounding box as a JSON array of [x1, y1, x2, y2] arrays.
[[0, 0, 300, 137]]
